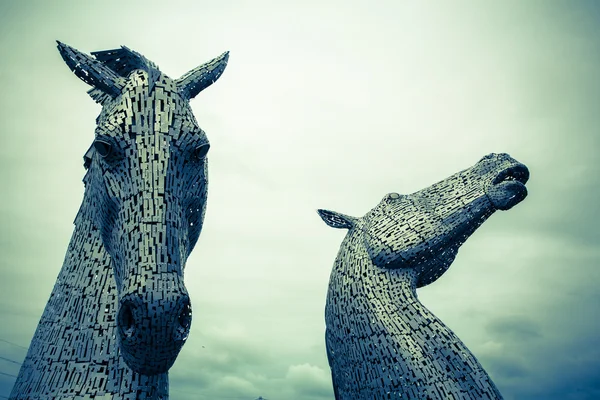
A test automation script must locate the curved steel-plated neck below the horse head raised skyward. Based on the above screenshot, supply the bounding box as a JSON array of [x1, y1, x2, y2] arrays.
[[325, 242, 502, 399]]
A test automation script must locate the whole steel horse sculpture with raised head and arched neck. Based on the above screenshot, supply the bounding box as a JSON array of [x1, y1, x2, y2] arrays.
[[319, 154, 529, 400]]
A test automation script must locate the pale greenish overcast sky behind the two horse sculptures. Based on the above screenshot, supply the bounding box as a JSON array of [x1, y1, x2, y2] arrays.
[[0, 0, 600, 400]]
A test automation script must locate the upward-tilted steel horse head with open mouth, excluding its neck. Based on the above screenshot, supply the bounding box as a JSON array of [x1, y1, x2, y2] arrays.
[[318, 153, 529, 288]]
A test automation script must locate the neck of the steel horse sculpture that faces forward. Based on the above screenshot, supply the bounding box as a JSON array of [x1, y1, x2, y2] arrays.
[[10, 191, 168, 399]]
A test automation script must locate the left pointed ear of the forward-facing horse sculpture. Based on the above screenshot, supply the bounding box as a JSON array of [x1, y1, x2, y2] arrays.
[[56, 40, 125, 98]]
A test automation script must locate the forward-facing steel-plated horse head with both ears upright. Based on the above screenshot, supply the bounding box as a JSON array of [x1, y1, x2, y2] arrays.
[[58, 42, 228, 375]]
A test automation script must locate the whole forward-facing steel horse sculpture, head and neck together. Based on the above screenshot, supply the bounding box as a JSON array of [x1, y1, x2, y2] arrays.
[[10, 42, 228, 399]]
